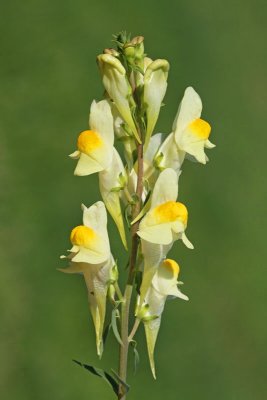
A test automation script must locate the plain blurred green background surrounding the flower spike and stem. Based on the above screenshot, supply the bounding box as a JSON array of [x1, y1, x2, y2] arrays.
[[0, 0, 267, 400]]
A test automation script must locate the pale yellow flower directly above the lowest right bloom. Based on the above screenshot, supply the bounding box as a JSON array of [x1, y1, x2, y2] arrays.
[[137, 168, 193, 304]]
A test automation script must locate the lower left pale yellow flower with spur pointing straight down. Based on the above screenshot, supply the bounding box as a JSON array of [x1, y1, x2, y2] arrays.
[[60, 201, 115, 356]]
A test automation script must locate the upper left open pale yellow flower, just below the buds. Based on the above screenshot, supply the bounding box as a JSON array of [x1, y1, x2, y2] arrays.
[[70, 100, 127, 248]]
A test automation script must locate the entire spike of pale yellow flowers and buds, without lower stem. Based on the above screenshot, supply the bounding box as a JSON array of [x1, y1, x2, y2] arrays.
[[61, 33, 214, 377]]
